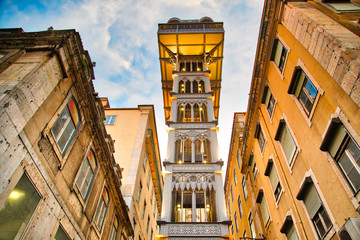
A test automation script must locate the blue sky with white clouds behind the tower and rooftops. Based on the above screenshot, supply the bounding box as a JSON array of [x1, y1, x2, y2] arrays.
[[0, 0, 263, 171]]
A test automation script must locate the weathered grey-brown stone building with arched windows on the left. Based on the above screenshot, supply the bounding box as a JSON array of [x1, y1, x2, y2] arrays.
[[0, 29, 133, 240]]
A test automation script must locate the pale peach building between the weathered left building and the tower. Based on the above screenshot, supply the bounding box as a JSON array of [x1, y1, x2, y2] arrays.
[[102, 102, 164, 240]]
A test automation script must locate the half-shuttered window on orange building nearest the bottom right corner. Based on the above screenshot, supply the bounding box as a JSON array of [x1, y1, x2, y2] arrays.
[[296, 177, 332, 239]]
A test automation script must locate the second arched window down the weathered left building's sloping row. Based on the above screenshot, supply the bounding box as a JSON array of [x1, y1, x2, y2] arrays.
[[75, 148, 97, 201]]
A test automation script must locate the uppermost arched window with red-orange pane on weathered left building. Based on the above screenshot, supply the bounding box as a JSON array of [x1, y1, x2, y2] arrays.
[[50, 98, 80, 156]]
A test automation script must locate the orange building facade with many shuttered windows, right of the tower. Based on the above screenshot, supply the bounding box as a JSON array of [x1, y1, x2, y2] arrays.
[[225, 1, 360, 240]]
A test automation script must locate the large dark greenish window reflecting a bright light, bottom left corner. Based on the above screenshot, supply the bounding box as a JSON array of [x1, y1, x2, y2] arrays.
[[0, 174, 41, 239]]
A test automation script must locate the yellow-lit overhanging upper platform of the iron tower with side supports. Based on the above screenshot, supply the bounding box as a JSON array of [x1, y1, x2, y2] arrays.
[[158, 17, 225, 120]]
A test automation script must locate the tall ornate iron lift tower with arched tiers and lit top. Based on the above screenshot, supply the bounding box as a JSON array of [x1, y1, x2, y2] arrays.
[[158, 17, 229, 239]]
